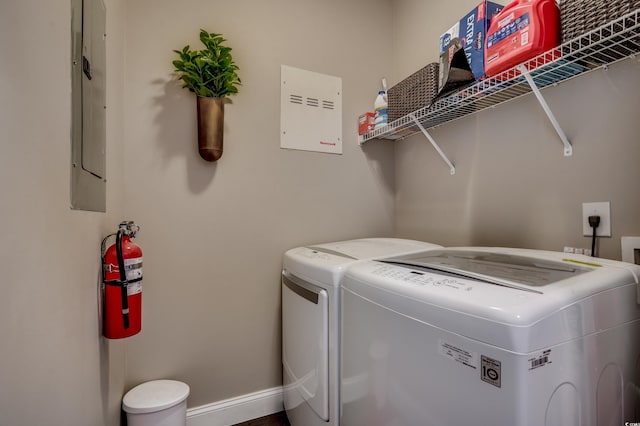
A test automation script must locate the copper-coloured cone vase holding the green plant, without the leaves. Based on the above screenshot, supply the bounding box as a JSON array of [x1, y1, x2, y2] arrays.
[[197, 96, 224, 161]]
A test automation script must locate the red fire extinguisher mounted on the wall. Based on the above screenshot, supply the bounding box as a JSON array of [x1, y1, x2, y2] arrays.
[[101, 222, 142, 339]]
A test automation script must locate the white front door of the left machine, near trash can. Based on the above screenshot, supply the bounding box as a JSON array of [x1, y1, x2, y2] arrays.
[[282, 275, 329, 421]]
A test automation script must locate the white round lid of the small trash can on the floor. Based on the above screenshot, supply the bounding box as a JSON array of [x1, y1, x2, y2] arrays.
[[122, 380, 189, 414]]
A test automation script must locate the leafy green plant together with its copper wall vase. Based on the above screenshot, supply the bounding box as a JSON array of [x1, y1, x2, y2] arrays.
[[173, 29, 241, 161]]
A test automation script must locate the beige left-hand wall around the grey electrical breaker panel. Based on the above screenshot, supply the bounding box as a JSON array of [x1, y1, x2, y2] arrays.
[[0, 0, 126, 426]]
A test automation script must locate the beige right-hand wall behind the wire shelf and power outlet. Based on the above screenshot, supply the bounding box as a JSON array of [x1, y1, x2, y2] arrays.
[[393, 0, 640, 259]]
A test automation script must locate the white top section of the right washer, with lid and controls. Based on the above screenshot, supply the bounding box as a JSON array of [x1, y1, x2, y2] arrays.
[[342, 248, 640, 353]]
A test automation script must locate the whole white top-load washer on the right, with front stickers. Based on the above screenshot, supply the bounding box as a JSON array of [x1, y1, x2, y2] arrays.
[[341, 248, 640, 426]]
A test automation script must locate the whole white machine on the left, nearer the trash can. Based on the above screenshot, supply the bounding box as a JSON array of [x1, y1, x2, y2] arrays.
[[282, 238, 441, 426]]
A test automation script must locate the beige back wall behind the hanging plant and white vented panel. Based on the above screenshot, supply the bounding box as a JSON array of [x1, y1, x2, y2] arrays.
[[125, 0, 394, 407]]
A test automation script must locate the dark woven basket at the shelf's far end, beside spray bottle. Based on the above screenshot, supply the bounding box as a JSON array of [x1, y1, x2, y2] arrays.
[[387, 62, 438, 122]]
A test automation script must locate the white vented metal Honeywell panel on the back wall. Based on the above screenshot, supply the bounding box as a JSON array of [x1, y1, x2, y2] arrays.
[[280, 65, 342, 154]]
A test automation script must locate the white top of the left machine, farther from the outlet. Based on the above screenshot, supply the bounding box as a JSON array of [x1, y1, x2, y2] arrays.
[[283, 238, 442, 287]]
